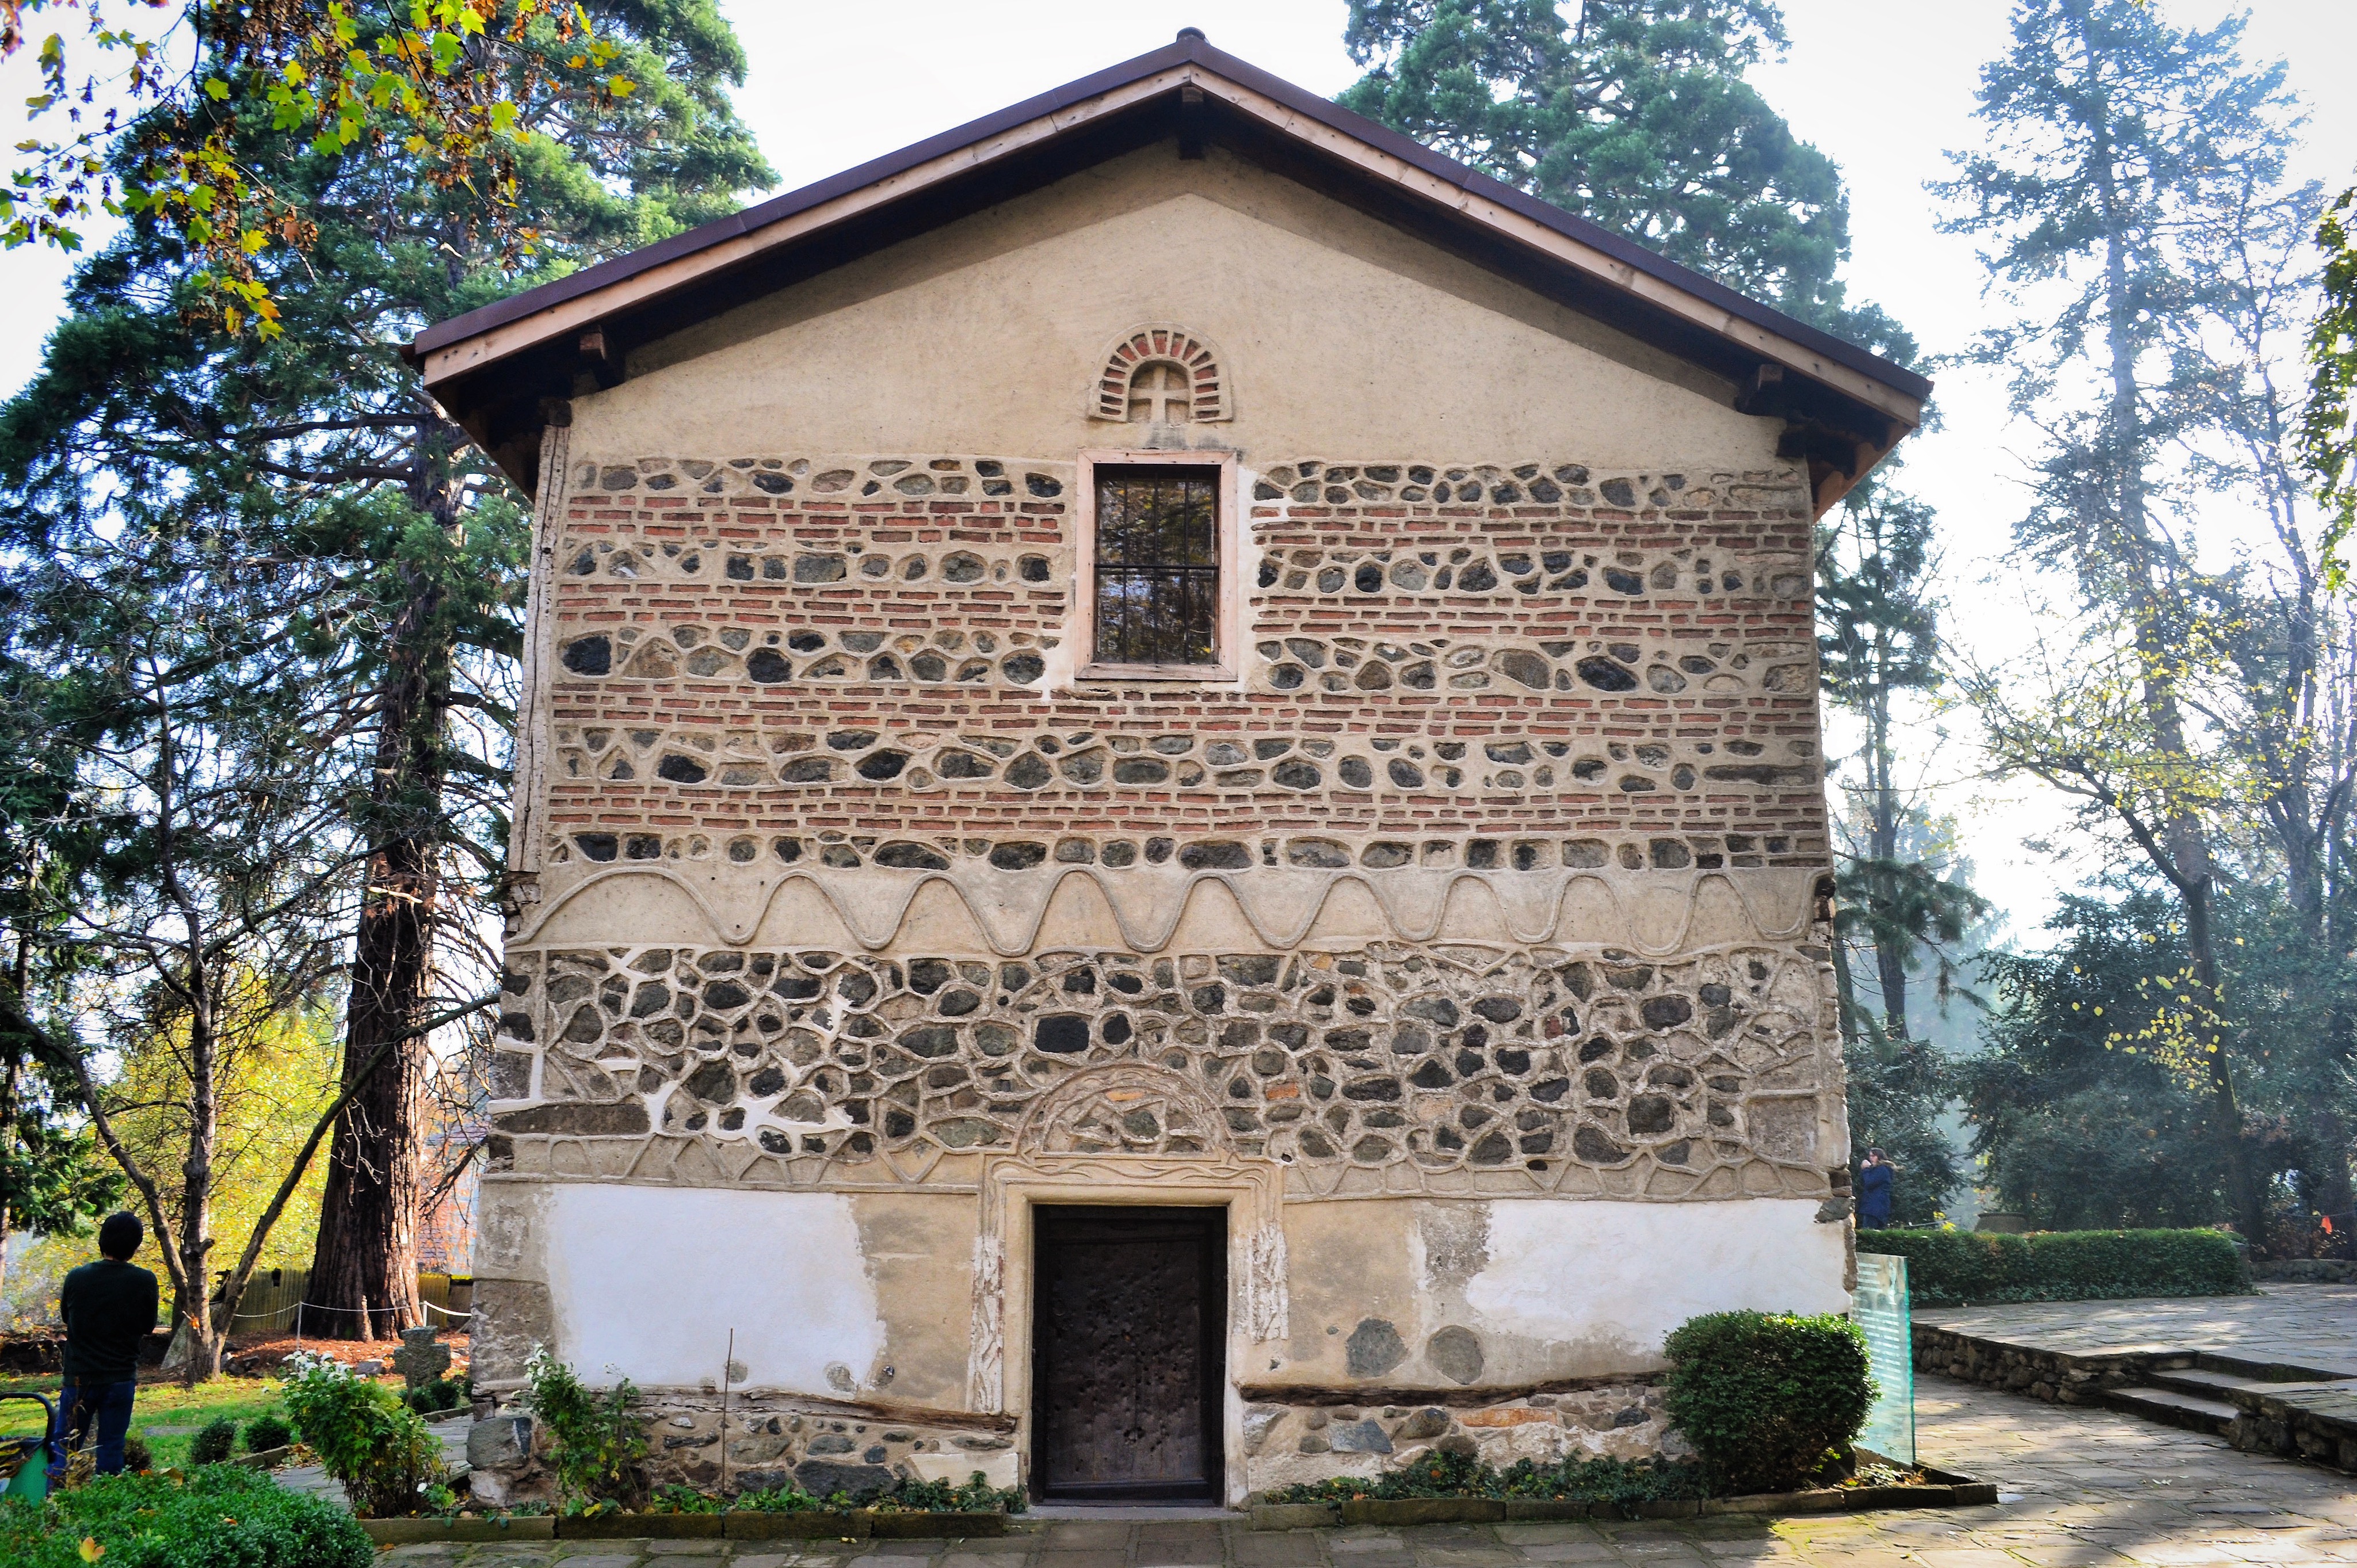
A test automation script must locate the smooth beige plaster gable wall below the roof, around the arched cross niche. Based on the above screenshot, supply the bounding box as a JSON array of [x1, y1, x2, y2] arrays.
[[573, 146, 1779, 469]]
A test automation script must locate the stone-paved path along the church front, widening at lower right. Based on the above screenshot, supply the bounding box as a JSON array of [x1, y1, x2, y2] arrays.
[[377, 1377, 2357, 1568]]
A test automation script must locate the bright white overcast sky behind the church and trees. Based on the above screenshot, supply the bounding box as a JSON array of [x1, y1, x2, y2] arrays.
[[0, 0, 2357, 932]]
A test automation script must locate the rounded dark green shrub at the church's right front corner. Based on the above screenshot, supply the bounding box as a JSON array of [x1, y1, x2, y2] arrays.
[[1662, 1311, 1874, 1493]]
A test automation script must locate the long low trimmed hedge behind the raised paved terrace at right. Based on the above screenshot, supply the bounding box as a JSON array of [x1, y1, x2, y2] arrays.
[[1858, 1231, 2251, 1306]]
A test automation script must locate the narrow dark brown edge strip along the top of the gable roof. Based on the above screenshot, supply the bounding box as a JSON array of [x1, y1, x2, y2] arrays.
[[406, 35, 1931, 399]]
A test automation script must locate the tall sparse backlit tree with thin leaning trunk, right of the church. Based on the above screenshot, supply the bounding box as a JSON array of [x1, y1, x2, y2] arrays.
[[1940, 0, 2291, 1238]]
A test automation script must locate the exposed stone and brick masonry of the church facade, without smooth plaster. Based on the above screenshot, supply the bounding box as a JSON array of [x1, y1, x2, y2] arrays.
[[478, 441, 1848, 1486]]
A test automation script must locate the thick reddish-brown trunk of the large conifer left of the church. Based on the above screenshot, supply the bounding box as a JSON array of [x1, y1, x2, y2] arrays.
[[302, 460, 457, 1340]]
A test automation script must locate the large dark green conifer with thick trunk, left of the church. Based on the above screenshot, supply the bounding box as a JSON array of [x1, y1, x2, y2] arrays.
[[0, 0, 771, 1337]]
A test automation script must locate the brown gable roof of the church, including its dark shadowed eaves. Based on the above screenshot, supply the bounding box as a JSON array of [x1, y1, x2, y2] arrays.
[[406, 28, 1931, 507]]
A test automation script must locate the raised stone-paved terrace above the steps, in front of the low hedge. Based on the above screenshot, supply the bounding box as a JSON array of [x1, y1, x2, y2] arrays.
[[1914, 1283, 2357, 1375]]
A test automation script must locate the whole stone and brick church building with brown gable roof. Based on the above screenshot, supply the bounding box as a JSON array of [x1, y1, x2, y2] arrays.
[[413, 30, 1928, 1504]]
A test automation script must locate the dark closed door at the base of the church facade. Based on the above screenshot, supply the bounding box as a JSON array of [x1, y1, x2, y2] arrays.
[[1032, 1207, 1228, 1500]]
